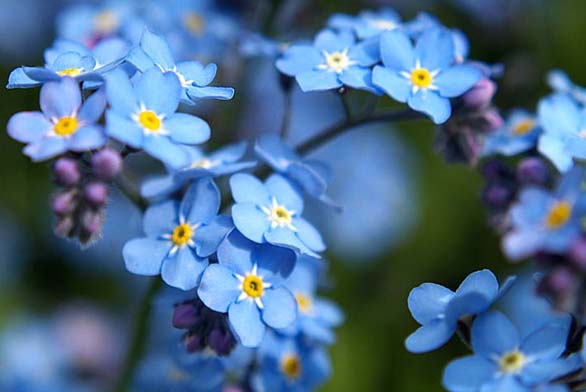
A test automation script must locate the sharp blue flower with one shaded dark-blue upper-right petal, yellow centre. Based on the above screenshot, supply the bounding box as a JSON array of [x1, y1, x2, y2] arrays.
[[197, 231, 297, 347]]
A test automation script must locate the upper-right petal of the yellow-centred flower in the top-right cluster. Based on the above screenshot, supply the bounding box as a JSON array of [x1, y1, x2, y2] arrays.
[[415, 28, 454, 71]]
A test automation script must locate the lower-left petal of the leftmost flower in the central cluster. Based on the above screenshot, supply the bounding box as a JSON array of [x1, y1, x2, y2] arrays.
[[122, 238, 171, 276]]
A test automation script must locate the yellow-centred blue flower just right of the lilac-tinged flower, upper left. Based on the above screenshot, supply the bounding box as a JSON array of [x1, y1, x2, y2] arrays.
[[105, 69, 210, 168]]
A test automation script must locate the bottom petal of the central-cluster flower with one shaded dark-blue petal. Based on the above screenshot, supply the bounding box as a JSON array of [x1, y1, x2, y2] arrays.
[[228, 300, 266, 348]]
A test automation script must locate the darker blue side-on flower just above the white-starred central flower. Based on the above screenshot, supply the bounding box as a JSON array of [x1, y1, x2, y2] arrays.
[[254, 134, 339, 208]]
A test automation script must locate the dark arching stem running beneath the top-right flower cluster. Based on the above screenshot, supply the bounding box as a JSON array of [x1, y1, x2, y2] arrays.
[[297, 109, 424, 155]]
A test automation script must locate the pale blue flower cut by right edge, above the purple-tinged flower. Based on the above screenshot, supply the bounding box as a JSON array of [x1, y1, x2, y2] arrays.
[[537, 93, 586, 172]]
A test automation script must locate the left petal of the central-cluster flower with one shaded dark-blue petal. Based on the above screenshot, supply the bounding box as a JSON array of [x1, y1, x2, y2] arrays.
[[197, 264, 240, 313]]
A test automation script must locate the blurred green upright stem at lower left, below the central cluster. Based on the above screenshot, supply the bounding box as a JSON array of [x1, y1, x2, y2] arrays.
[[114, 277, 163, 392]]
